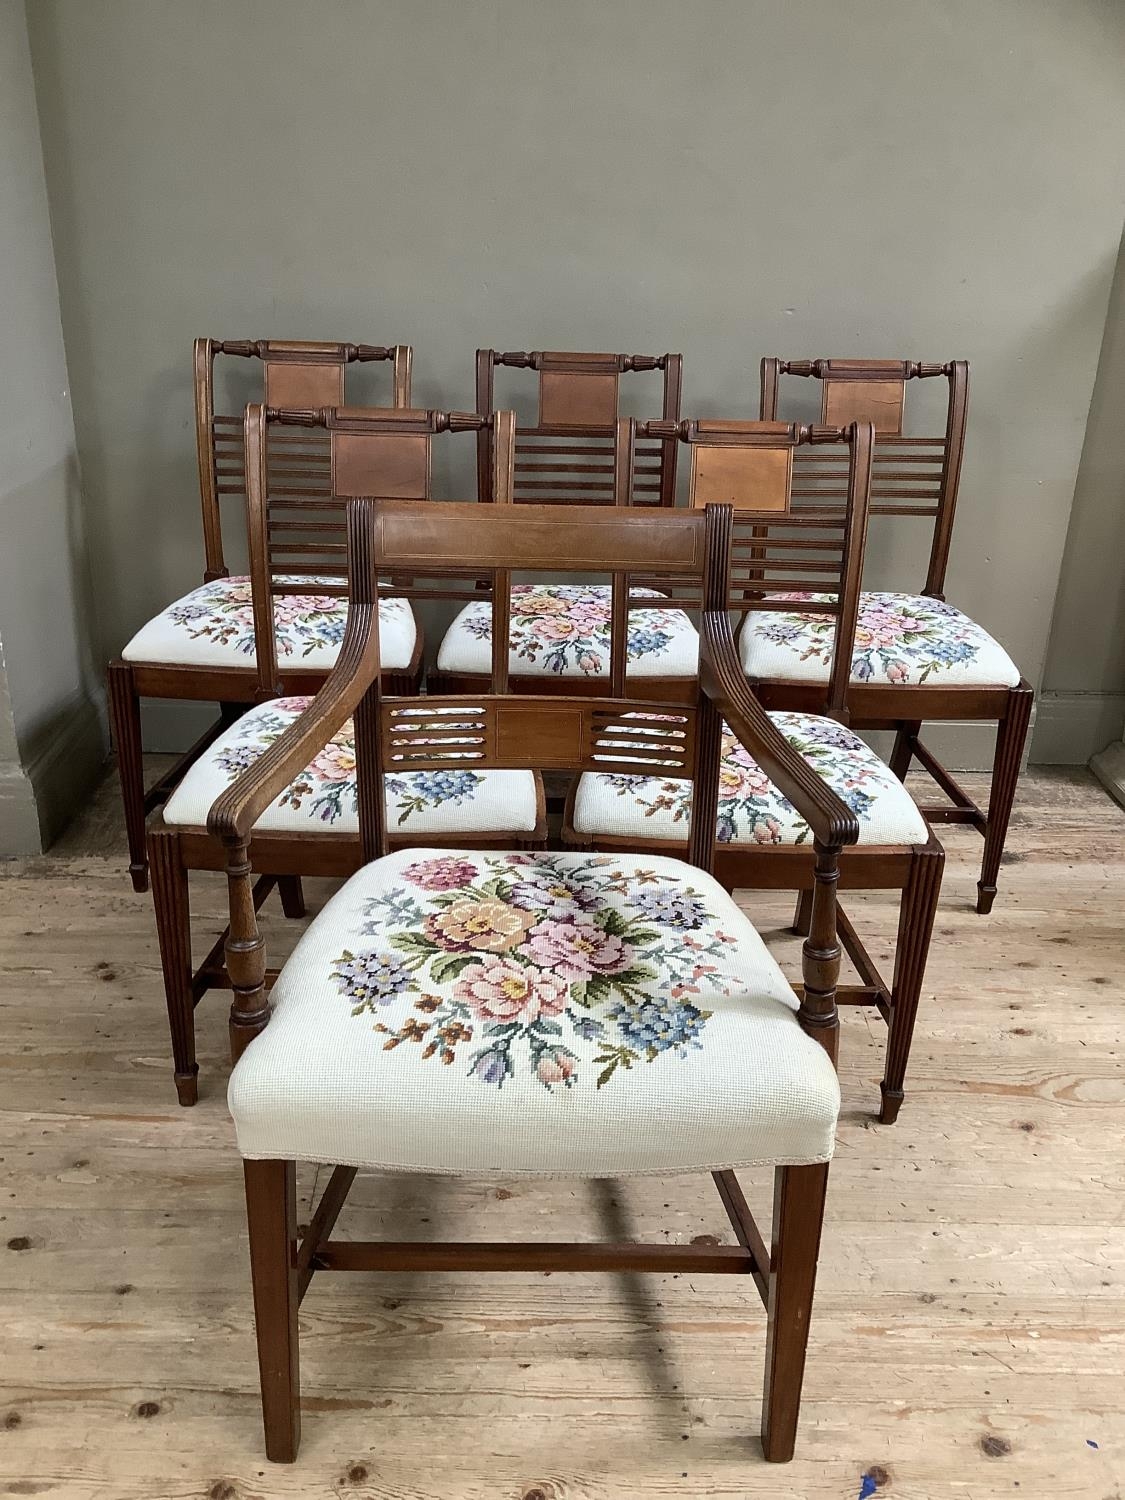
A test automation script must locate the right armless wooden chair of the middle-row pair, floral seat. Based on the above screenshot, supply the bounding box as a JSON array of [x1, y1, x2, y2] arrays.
[[563, 420, 945, 1124]]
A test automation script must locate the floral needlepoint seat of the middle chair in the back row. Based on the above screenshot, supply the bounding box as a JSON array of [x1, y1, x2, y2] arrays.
[[438, 584, 699, 678]]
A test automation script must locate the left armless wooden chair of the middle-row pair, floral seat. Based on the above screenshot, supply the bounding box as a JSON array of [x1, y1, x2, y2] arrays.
[[147, 404, 546, 1106]]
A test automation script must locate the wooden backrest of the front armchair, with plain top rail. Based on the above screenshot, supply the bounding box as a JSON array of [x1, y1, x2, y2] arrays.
[[348, 500, 732, 869]]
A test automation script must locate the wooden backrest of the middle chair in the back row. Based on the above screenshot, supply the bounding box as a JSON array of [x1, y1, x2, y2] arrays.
[[477, 350, 683, 509]]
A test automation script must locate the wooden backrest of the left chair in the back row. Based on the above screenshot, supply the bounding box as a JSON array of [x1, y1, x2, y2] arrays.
[[194, 339, 413, 582]]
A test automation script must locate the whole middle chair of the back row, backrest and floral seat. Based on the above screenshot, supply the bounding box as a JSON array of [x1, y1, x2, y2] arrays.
[[429, 350, 699, 698]]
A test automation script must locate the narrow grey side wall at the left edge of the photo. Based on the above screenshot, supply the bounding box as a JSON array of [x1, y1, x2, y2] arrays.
[[0, 0, 105, 854]]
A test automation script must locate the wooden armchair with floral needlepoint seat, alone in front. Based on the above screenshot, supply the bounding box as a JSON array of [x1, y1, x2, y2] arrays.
[[209, 500, 858, 1461]]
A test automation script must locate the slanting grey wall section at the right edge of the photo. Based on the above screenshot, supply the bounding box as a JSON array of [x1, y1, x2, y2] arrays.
[[1032, 228, 1125, 764]]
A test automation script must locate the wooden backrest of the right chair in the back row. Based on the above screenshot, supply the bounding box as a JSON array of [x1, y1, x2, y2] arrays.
[[761, 359, 969, 599]]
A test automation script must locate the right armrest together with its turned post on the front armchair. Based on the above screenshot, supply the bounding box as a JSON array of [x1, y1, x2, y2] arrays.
[[699, 611, 860, 1062]]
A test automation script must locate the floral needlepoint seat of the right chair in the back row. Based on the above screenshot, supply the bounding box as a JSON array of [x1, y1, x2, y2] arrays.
[[740, 594, 1020, 687]]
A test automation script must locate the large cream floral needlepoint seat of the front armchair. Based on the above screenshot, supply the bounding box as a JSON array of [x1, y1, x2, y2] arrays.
[[230, 849, 840, 1176]]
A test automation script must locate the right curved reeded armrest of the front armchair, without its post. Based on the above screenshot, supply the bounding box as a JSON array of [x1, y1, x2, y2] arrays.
[[699, 611, 860, 848]]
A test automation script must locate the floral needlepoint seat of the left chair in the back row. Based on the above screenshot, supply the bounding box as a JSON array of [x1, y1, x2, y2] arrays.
[[122, 576, 417, 672]]
